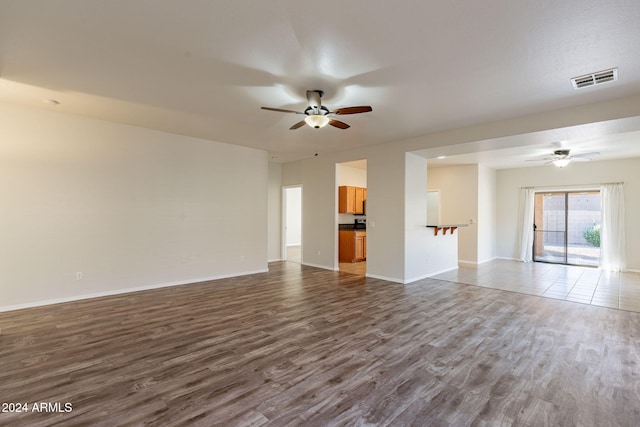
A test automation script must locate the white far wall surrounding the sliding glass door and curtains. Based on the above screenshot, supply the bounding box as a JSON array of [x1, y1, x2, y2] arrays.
[[496, 157, 640, 270]]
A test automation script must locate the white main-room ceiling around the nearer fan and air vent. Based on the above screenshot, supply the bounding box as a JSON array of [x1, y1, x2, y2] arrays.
[[0, 0, 640, 162]]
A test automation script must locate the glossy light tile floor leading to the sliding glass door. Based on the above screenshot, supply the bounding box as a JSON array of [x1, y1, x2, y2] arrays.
[[432, 260, 640, 312]]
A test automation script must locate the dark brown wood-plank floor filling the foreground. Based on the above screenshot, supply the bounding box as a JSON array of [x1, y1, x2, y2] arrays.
[[0, 262, 640, 426]]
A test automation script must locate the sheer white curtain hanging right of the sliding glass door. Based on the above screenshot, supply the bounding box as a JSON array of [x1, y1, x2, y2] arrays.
[[600, 183, 626, 271]]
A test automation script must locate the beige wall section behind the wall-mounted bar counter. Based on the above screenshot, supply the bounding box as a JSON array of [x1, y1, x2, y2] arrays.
[[428, 165, 478, 263]]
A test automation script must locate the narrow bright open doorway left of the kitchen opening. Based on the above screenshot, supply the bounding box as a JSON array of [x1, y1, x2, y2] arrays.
[[282, 186, 302, 263]]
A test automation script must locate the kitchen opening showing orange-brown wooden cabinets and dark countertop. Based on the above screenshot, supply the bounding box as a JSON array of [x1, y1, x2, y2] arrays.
[[336, 159, 367, 276]]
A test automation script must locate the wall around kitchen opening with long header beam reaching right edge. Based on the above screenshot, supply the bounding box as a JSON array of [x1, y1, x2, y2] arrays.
[[282, 96, 640, 282]]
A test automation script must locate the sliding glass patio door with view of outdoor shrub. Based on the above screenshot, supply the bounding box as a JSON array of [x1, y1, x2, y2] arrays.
[[533, 190, 601, 267]]
